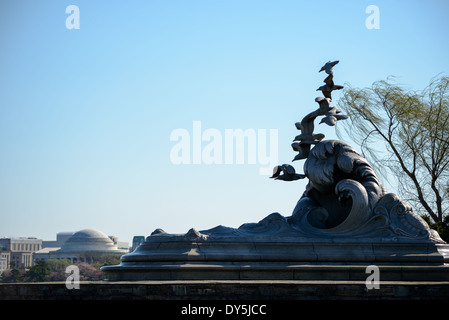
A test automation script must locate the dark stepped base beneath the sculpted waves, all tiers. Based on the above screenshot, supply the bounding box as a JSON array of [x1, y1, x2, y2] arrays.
[[102, 238, 449, 281]]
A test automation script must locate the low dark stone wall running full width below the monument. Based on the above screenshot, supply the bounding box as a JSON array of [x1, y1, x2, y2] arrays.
[[0, 280, 449, 300]]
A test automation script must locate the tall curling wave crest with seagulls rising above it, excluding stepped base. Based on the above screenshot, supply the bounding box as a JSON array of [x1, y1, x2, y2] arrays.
[[273, 60, 443, 242]]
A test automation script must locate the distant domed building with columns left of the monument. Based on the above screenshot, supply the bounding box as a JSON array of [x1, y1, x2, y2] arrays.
[[34, 229, 129, 263]]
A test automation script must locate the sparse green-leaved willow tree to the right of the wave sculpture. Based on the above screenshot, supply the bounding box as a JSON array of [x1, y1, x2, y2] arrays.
[[338, 77, 449, 230]]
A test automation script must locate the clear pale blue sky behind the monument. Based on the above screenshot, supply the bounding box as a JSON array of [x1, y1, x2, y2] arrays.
[[0, 0, 449, 242]]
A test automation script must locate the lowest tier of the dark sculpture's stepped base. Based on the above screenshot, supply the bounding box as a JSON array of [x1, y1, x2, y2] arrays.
[[102, 262, 449, 281]]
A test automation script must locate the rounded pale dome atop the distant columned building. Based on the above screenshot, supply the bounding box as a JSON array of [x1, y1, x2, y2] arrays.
[[60, 229, 117, 252]]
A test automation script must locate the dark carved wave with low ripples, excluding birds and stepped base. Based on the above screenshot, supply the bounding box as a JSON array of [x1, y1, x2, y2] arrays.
[[147, 140, 445, 243]]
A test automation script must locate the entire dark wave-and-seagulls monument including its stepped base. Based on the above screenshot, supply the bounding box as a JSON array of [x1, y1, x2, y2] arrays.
[[102, 61, 449, 280]]
